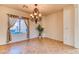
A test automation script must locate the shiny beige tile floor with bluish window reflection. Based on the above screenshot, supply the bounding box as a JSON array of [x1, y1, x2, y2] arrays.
[[0, 38, 79, 54]]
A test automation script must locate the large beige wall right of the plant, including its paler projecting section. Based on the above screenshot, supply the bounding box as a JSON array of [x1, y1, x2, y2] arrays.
[[43, 6, 74, 46]]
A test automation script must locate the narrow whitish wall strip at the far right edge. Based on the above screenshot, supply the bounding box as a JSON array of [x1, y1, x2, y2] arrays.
[[74, 5, 79, 48]]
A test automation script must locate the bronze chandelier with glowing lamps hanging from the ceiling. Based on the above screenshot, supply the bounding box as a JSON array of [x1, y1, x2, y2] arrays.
[[30, 4, 42, 24]]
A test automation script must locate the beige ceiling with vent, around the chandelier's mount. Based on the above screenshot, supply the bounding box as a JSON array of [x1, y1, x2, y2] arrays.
[[2, 4, 72, 15]]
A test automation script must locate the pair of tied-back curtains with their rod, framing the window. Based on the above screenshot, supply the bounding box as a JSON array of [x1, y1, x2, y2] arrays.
[[7, 15, 29, 42]]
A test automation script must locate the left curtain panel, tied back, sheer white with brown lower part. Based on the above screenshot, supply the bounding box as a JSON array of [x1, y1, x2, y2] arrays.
[[7, 16, 18, 42]]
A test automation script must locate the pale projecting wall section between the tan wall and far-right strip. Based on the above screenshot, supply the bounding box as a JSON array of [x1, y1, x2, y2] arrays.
[[63, 6, 75, 46]]
